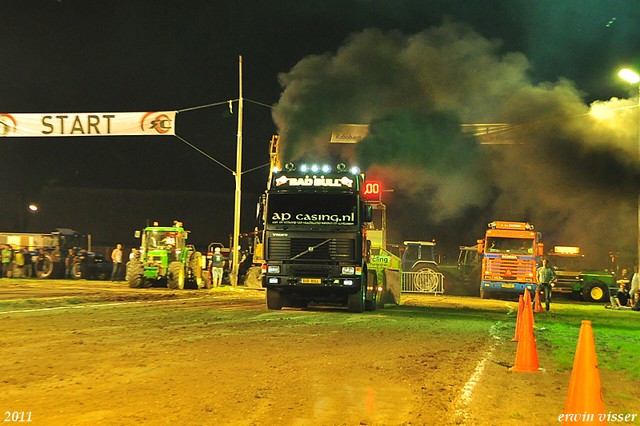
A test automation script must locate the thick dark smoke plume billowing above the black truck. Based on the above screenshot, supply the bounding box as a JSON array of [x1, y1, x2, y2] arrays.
[[273, 23, 639, 266]]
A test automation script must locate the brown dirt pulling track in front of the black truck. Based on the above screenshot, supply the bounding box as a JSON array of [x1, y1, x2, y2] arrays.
[[0, 280, 640, 426]]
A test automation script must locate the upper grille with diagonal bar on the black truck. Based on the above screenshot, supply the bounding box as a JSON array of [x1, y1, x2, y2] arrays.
[[267, 237, 356, 260]]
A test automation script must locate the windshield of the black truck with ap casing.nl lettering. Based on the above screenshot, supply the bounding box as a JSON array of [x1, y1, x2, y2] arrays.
[[267, 193, 358, 226]]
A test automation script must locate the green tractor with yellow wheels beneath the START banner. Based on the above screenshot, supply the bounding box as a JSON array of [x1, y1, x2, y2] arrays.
[[126, 222, 206, 289]]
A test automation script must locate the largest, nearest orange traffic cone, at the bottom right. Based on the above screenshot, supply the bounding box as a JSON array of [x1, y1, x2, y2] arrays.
[[563, 321, 607, 425]]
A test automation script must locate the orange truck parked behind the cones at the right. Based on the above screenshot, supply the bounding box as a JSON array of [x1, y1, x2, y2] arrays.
[[478, 221, 544, 299]]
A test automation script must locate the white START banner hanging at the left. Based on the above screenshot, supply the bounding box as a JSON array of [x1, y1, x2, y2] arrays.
[[0, 111, 176, 137]]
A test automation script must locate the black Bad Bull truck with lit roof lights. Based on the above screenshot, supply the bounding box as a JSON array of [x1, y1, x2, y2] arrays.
[[262, 163, 379, 313]]
